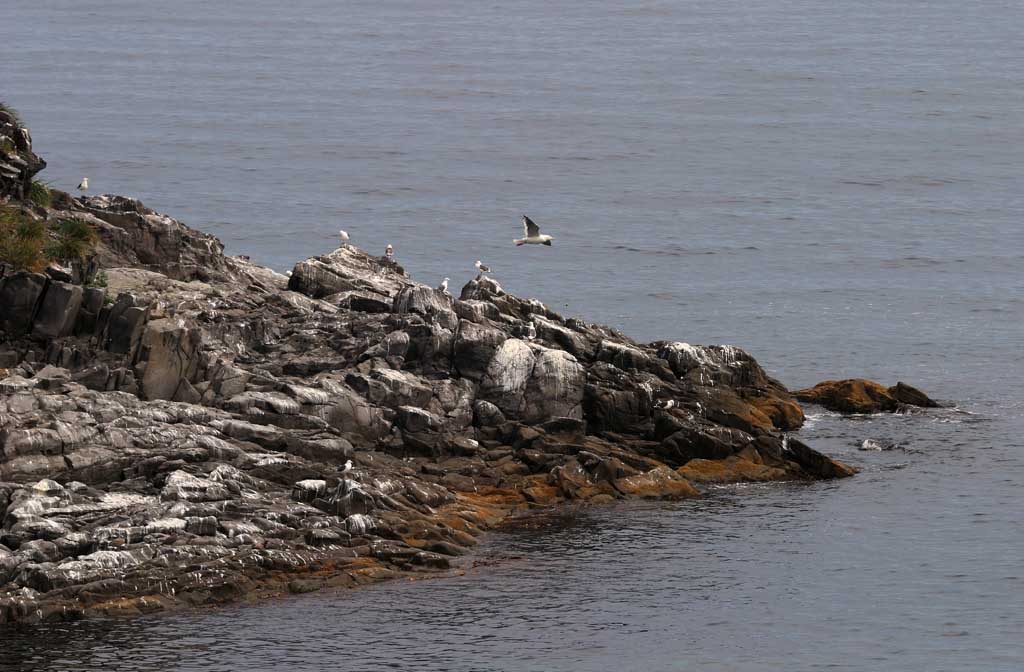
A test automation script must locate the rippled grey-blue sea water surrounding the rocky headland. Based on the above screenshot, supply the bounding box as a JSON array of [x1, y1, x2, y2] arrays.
[[0, 0, 1024, 672]]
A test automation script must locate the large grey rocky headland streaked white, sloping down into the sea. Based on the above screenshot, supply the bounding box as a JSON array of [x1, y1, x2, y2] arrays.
[[0, 111, 888, 623]]
